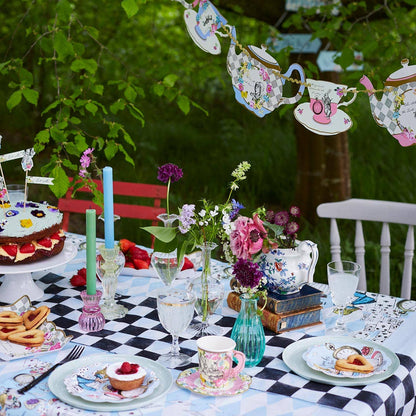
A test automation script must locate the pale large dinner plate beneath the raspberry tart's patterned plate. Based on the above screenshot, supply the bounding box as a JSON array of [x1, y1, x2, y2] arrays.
[[48, 353, 172, 412]]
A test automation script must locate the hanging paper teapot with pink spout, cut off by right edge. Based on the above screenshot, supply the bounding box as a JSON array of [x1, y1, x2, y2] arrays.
[[360, 59, 416, 147]]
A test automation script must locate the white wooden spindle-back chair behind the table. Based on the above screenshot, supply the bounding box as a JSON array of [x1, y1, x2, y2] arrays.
[[317, 199, 416, 299]]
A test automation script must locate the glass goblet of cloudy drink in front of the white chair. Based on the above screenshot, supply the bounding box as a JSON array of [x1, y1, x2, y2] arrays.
[[327, 260, 361, 335]]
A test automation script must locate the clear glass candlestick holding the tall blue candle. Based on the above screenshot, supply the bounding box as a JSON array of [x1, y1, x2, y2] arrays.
[[97, 244, 127, 320]]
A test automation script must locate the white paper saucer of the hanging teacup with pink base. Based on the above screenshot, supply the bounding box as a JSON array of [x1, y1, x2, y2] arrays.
[[293, 102, 352, 136]]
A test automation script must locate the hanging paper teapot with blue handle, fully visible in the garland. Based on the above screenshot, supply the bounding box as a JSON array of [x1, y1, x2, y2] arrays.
[[227, 27, 305, 117]]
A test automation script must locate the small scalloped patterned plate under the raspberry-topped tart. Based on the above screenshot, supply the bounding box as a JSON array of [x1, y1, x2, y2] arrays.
[[64, 362, 159, 403]]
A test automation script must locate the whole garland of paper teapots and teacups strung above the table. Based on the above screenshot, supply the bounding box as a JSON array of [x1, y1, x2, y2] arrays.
[[172, 0, 416, 147]]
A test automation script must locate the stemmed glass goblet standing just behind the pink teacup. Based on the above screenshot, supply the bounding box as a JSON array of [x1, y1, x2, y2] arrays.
[[157, 287, 196, 368]]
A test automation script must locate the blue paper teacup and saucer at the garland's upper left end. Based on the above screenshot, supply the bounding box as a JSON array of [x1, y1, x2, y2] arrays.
[[184, 0, 227, 55]]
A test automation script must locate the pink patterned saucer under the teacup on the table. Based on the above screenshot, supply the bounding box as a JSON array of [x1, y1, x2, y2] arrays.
[[176, 367, 251, 396]]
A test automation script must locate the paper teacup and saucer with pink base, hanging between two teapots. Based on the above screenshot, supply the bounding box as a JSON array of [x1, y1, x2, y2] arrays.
[[293, 78, 357, 136]]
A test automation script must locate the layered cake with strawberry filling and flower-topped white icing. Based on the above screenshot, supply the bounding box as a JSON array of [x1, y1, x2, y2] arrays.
[[0, 201, 65, 265]]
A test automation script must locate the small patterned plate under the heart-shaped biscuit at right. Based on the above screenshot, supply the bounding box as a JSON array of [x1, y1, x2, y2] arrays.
[[302, 341, 391, 378]]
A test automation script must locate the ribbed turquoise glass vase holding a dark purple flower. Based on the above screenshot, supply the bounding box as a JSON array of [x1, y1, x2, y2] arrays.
[[231, 295, 266, 367]]
